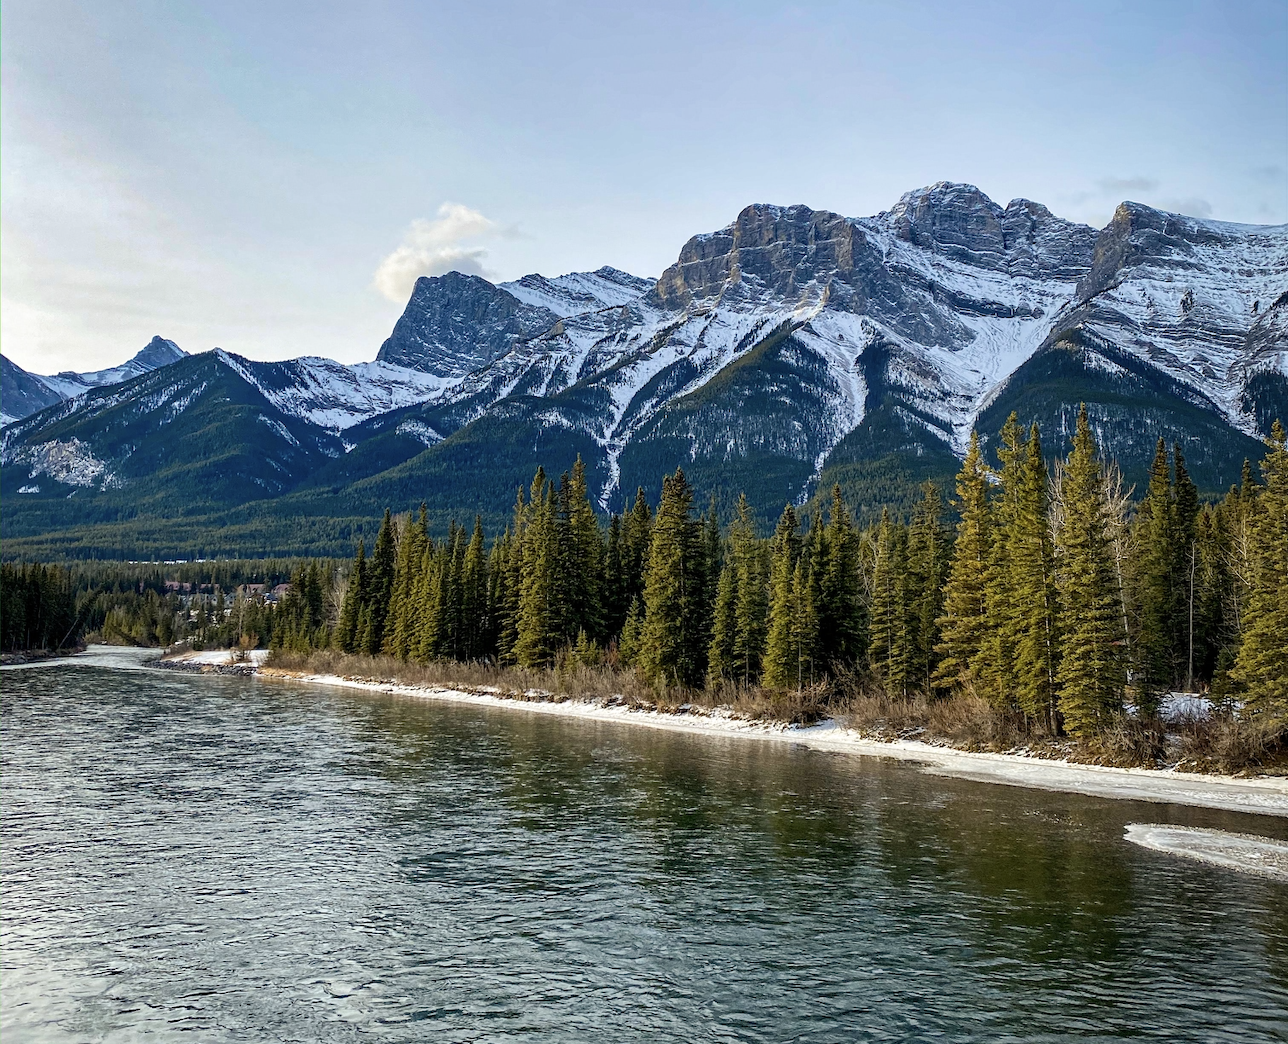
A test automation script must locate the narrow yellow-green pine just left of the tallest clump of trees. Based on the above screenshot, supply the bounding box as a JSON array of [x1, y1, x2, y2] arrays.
[[934, 431, 993, 691]]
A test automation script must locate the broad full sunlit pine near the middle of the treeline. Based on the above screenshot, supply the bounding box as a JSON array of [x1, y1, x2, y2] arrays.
[[639, 469, 706, 685]]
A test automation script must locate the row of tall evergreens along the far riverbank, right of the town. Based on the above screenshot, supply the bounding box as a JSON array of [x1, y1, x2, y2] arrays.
[[322, 409, 1288, 735]]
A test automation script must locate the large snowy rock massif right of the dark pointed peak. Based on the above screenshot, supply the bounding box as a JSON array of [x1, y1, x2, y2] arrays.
[[396, 183, 1288, 514]]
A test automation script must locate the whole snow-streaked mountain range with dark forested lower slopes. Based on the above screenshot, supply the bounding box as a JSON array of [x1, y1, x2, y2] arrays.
[[0, 183, 1288, 563]]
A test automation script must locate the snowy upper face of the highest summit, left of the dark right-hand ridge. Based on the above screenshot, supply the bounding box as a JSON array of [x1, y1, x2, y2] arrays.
[[419, 185, 1096, 496]]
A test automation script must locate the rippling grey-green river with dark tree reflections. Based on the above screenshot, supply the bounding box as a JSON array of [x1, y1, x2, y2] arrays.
[[0, 654, 1288, 1044]]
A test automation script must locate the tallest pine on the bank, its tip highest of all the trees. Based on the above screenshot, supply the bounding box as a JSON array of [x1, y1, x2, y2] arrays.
[[1055, 405, 1126, 736]]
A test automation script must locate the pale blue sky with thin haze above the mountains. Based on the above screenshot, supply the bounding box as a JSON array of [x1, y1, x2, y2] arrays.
[[0, 0, 1288, 372]]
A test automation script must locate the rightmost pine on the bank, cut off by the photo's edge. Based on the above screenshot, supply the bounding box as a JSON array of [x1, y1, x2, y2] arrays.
[[1230, 421, 1288, 723]]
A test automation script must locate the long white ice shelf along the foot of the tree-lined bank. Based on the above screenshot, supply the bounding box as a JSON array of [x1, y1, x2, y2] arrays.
[[242, 668, 1288, 817]]
